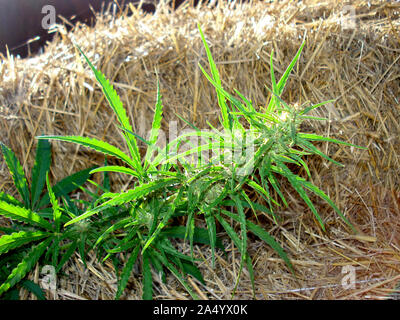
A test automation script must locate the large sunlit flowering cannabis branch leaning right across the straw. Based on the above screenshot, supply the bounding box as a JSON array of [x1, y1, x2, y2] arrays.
[[26, 22, 368, 299]]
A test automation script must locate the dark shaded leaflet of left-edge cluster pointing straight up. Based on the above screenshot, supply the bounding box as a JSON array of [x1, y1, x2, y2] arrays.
[[31, 140, 51, 210]]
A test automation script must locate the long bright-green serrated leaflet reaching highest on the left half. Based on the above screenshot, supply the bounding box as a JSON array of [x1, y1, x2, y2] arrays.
[[77, 47, 142, 172]]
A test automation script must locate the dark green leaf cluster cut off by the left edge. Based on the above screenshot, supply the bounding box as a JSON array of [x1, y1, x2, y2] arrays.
[[0, 140, 93, 297]]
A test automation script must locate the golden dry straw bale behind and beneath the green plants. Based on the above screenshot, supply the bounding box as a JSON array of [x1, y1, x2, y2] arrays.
[[0, 1, 400, 299]]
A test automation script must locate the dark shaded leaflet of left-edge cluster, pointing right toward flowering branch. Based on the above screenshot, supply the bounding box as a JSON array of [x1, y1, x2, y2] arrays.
[[38, 167, 95, 208]]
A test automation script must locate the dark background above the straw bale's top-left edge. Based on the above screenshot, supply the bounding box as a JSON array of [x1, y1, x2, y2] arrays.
[[0, 0, 231, 58]]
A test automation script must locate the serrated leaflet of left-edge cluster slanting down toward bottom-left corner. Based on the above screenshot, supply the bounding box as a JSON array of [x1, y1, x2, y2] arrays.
[[0, 237, 53, 295]]
